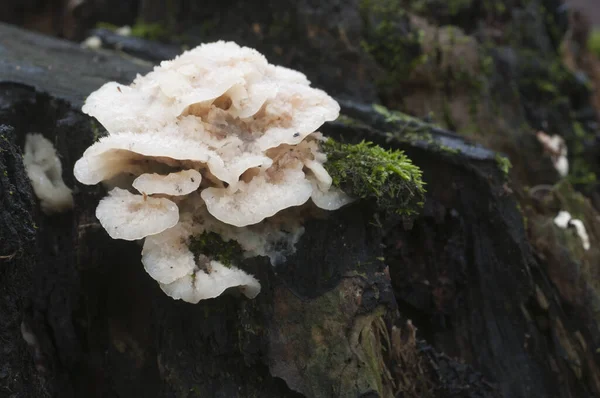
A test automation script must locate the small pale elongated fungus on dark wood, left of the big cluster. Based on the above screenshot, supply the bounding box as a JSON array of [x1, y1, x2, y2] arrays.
[[23, 134, 73, 214]]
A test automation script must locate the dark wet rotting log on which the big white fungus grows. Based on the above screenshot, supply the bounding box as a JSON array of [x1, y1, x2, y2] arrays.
[[0, 20, 598, 397]]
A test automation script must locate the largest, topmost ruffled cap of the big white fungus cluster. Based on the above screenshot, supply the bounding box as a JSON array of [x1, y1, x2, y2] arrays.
[[75, 42, 340, 190]]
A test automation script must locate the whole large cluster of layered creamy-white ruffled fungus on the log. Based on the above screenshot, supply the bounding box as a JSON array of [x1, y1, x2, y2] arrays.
[[74, 41, 352, 303]]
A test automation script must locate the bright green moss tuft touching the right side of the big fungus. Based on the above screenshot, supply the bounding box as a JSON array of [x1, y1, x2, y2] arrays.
[[322, 139, 425, 215]]
